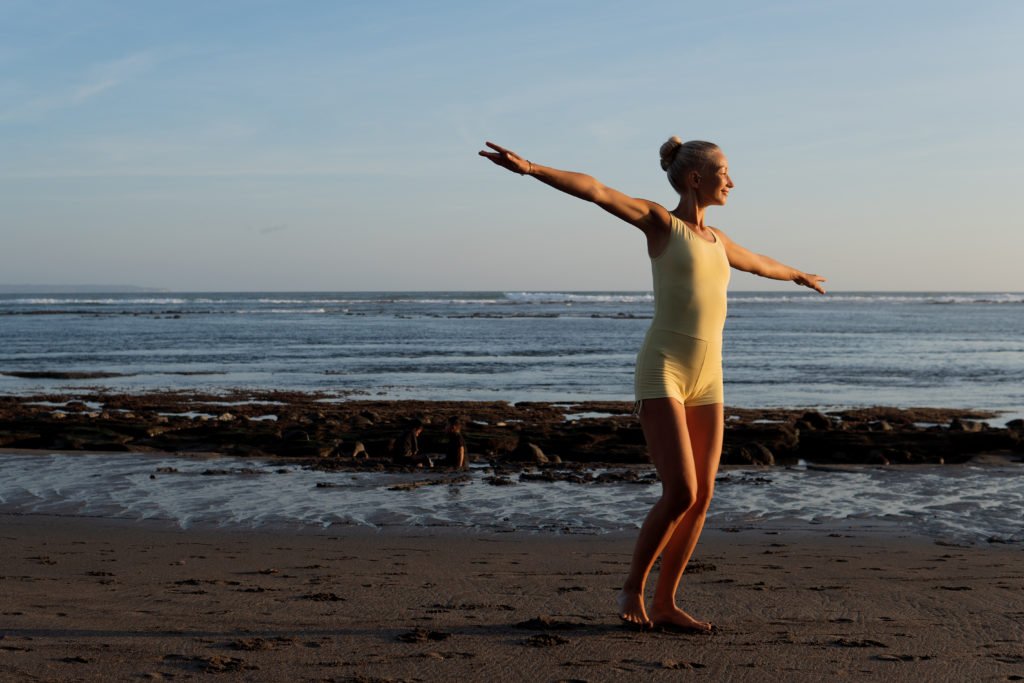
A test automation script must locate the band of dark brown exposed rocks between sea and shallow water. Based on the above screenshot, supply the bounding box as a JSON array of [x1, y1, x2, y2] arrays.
[[0, 391, 1024, 469]]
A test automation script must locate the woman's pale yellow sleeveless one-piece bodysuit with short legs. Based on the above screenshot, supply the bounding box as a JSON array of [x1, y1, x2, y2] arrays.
[[634, 214, 729, 414]]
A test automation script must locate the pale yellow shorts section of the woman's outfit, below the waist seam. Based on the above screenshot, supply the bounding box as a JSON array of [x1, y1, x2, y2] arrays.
[[633, 330, 725, 415]]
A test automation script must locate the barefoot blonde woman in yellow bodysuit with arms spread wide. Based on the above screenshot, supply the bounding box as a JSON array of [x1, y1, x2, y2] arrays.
[[480, 137, 825, 632]]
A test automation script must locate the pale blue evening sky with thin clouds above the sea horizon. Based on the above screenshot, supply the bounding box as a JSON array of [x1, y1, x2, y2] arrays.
[[0, 0, 1024, 292]]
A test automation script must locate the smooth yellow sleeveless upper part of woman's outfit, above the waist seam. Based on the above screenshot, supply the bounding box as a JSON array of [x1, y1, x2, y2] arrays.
[[650, 214, 730, 345]]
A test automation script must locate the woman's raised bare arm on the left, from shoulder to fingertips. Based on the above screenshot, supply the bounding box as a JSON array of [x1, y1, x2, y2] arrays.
[[480, 142, 671, 232]]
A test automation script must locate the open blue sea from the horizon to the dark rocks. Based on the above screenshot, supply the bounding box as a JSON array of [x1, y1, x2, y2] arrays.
[[0, 290, 1024, 422]]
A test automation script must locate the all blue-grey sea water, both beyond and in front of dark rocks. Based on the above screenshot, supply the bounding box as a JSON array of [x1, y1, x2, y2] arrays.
[[0, 292, 1024, 543]]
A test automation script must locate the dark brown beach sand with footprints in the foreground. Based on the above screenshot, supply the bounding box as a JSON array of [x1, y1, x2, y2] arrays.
[[0, 515, 1024, 682]]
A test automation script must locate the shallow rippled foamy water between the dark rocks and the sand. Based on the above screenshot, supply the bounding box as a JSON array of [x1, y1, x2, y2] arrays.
[[0, 454, 1024, 542]]
